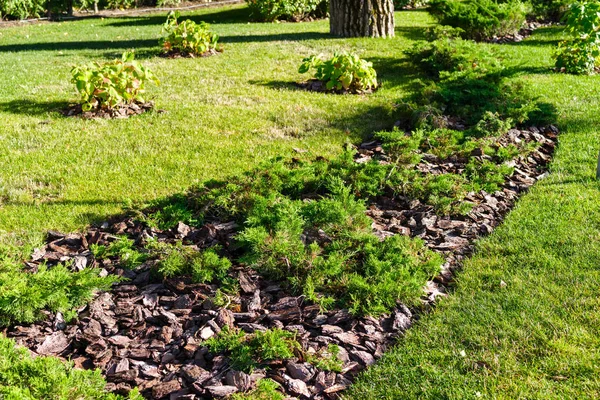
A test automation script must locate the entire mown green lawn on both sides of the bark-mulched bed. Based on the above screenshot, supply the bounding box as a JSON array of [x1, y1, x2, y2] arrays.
[[0, 7, 600, 399]]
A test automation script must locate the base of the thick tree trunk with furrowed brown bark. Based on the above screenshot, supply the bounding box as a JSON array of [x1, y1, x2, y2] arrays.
[[329, 0, 394, 37]]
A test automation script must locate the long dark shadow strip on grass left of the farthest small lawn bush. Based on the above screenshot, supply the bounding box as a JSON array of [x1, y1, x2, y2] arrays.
[[0, 39, 158, 56]]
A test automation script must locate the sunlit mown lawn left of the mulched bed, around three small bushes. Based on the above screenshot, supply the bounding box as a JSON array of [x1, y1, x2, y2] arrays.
[[0, 6, 430, 252]]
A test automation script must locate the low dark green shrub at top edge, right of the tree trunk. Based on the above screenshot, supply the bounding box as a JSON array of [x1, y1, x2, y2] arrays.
[[429, 0, 527, 40]]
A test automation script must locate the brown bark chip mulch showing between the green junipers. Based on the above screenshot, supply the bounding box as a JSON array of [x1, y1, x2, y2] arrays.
[[5, 126, 558, 400]]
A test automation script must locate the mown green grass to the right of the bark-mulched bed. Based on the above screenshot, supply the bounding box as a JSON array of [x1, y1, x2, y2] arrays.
[[347, 28, 600, 399]]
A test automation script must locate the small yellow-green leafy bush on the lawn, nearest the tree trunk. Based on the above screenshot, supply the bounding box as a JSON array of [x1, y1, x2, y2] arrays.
[[298, 53, 377, 92]]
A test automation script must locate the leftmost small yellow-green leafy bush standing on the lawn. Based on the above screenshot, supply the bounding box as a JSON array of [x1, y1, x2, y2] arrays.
[[71, 52, 159, 111]]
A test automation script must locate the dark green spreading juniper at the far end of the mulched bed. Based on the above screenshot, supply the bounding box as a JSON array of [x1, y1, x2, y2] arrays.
[[398, 38, 554, 128]]
